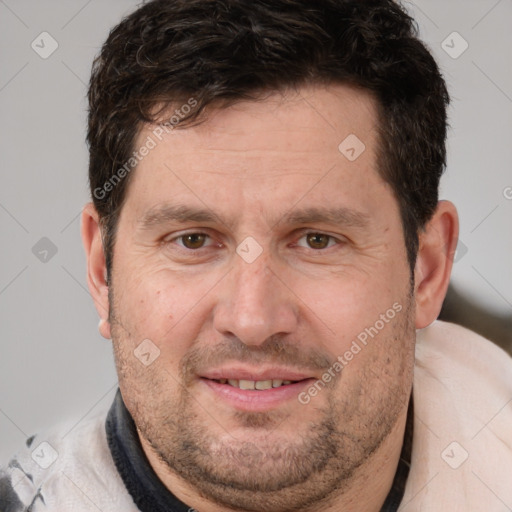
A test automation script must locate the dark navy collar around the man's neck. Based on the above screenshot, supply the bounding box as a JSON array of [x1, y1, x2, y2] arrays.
[[106, 390, 413, 512]]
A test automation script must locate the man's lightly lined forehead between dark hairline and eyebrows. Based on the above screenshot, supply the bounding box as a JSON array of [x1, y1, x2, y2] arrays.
[[124, 85, 384, 224]]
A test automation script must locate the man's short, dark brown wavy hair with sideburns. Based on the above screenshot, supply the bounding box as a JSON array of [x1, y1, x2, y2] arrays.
[[87, 0, 449, 280]]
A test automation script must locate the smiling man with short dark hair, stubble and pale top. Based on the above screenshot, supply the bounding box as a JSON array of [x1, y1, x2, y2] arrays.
[[0, 0, 512, 512]]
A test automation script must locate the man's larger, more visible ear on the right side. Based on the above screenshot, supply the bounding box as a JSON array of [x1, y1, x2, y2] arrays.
[[414, 201, 459, 329]]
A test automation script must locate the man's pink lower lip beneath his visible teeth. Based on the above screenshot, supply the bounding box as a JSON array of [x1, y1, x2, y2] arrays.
[[200, 377, 315, 412]]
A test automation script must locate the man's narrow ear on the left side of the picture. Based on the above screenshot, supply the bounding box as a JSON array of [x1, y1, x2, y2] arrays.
[[82, 203, 111, 339]]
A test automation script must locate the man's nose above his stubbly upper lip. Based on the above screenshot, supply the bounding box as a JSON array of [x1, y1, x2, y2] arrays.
[[213, 255, 298, 346]]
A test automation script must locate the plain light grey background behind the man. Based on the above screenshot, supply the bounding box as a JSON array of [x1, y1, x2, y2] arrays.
[[0, 0, 512, 461]]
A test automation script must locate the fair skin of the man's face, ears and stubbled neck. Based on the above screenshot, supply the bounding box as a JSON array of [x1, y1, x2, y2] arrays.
[[82, 85, 458, 512]]
